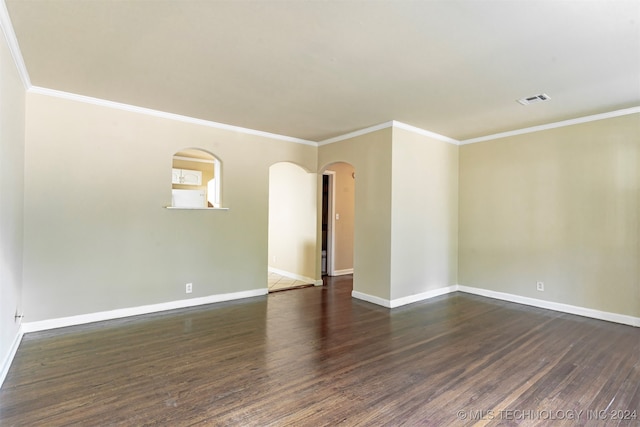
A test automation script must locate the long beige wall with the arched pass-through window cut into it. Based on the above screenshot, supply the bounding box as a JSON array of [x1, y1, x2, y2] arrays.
[[23, 93, 317, 321]]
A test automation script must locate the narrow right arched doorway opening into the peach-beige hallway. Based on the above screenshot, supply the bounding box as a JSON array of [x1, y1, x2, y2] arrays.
[[320, 162, 356, 276]]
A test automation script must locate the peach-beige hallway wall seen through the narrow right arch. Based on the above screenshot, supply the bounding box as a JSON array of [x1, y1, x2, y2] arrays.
[[326, 162, 356, 274]]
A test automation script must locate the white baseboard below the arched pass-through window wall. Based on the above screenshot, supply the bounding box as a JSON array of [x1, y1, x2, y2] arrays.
[[22, 288, 268, 333]]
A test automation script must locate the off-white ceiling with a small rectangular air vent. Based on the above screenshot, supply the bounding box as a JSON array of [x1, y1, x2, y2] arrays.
[[6, 0, 640, 141]]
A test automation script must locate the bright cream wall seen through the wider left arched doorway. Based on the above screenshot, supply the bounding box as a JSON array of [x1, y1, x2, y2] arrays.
[[268, 162, 320, 280]]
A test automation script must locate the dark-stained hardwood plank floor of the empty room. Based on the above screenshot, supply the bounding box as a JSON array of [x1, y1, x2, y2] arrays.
[[0, 277, 640, 426]]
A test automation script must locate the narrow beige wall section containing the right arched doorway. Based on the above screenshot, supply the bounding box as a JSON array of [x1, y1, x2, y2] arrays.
[[317, 128, 391, 300]]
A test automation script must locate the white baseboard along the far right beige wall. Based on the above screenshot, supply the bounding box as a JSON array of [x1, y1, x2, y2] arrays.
[[457, 285, 640, 327]]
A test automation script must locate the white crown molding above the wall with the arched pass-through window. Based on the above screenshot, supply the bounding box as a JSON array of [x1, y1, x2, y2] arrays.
[[27, 86, 318, 147]]
